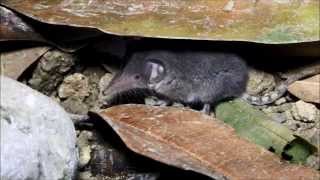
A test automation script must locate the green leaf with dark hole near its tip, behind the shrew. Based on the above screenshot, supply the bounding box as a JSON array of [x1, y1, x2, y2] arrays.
[[215, 100, 316, 163]]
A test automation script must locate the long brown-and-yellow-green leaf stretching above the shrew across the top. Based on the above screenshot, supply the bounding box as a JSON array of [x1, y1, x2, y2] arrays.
[[2, 0, 319, 43]]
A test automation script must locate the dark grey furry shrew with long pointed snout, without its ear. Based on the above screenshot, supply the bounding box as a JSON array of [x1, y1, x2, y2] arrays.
[[104, 50, 248, 104]]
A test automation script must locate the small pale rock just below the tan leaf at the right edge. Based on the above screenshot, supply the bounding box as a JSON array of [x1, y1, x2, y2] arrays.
[[291, 100, 320, 122]]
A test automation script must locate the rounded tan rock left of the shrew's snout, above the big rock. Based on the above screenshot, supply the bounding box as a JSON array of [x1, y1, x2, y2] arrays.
[[58, 73, 89, 100]]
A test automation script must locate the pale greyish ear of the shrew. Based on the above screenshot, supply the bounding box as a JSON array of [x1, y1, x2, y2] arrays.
[[146, 61, 165, 84]]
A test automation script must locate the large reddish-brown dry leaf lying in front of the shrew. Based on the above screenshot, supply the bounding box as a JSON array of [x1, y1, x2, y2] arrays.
[[99, 105, 320, 180]]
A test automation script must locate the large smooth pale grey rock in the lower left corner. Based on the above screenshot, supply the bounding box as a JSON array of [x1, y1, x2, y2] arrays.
[[0, 76, 78, 180]]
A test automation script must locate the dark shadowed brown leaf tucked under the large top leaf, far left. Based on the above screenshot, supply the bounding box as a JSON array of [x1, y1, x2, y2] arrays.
[[0, 5, 103, 52]]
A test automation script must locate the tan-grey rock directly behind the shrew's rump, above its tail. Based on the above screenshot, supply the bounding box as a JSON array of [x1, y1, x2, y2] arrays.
[[247, 69, 276, 95]]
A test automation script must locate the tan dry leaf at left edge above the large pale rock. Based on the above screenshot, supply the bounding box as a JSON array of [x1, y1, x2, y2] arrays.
[[0, 47, 49, 79]]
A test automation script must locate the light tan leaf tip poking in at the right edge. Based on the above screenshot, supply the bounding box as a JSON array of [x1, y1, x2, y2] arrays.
[[288, 74, 320, 104]]
